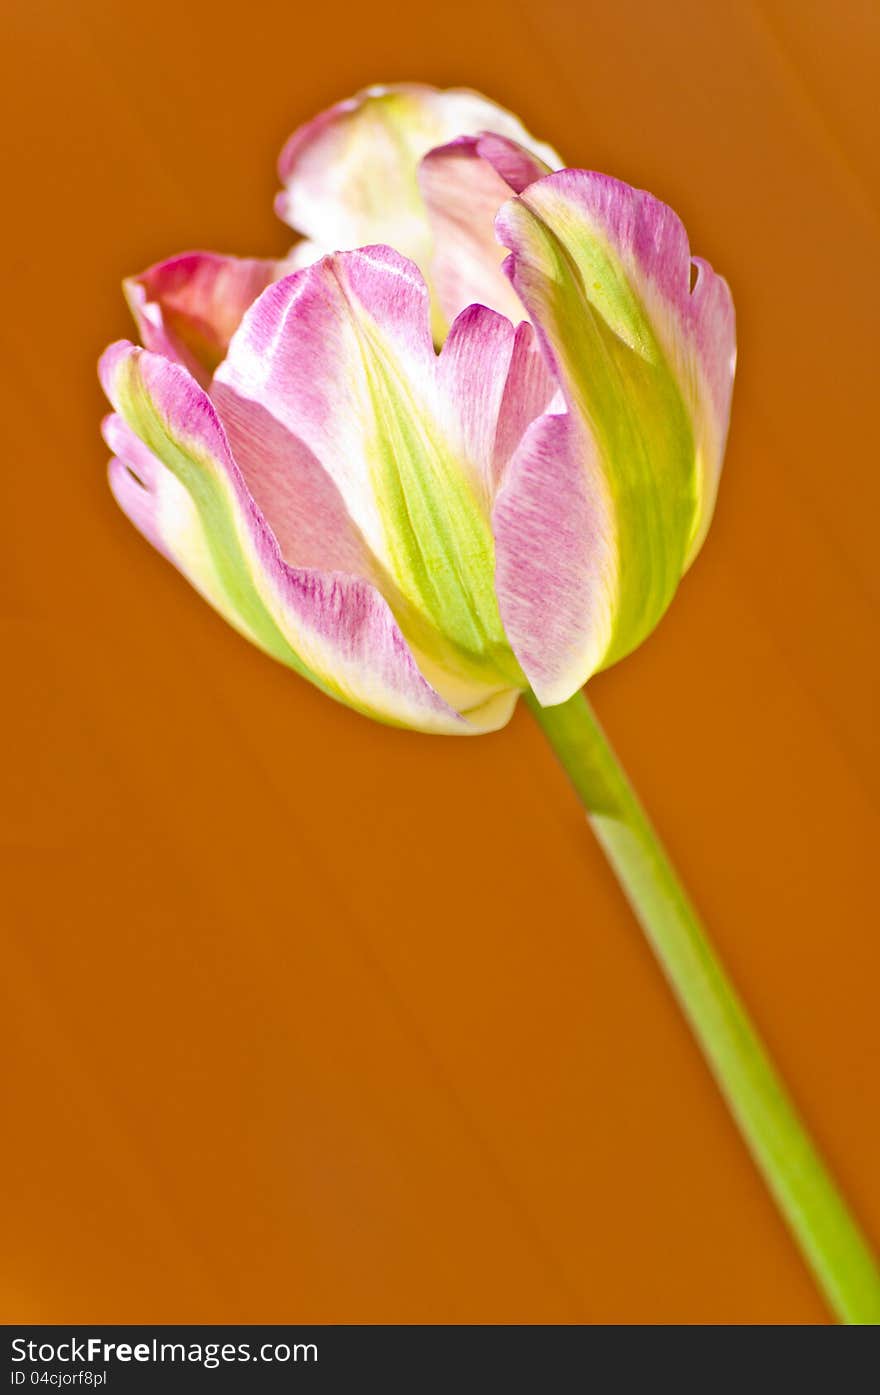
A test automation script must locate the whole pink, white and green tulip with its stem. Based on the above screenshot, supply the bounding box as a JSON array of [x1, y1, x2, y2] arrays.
[[100, 85, 880, 1321]]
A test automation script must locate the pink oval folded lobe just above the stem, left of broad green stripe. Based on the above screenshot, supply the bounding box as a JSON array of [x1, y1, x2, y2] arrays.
[[494, 414, 616, 706]]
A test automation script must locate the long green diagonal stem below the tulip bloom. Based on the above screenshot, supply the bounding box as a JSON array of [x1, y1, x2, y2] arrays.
[[529, 693, 880, 1324]]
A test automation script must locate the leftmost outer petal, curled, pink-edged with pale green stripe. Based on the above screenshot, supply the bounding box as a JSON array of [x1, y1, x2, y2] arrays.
[[100, 343, 512, 734]]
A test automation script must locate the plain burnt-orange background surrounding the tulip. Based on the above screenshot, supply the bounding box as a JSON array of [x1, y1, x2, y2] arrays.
[[0, 0, 880, 1322]]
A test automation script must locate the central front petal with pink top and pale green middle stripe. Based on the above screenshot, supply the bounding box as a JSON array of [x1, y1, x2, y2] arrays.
[[215, 247, 554, 706]]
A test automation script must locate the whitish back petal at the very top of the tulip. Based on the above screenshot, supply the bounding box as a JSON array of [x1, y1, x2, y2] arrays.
[[276, 84, 562, 330]]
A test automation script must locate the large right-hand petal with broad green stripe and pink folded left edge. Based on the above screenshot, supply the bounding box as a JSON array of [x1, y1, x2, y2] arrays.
[[496, 170, 735, 702]]
